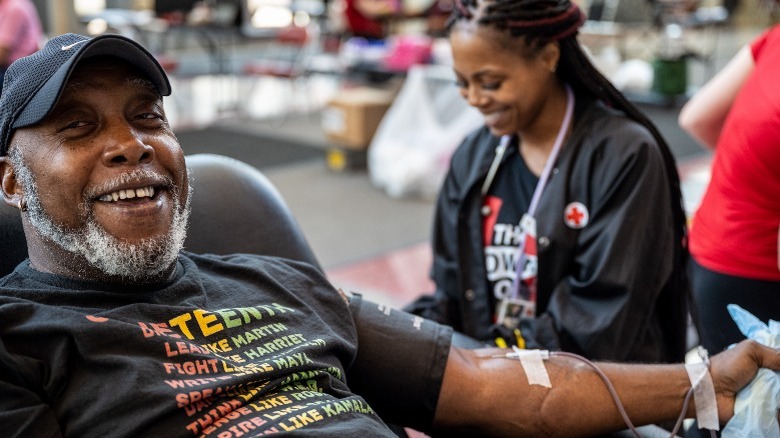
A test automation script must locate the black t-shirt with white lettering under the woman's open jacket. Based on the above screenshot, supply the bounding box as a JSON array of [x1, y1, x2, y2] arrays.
[[482, 147, 539, 316]]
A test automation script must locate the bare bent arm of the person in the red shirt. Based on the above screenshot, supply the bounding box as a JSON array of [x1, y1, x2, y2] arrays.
[[678, 46, 754, 148]]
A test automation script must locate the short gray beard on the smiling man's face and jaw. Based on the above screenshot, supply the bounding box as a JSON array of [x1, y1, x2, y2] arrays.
[[9, 148, 190, 281]]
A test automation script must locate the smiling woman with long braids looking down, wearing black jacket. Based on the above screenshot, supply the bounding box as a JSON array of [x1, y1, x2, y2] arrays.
[[406, 0, 688, 362]]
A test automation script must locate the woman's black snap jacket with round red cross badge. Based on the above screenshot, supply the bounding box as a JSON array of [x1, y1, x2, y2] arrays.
[[406, 96, 687, 362]]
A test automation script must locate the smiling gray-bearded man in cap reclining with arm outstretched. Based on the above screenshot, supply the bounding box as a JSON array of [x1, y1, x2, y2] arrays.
[[0, 34, 780, 437]]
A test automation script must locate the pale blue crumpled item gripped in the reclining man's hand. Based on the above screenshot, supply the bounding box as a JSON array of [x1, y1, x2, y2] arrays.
[[721, 304, 780, 438]]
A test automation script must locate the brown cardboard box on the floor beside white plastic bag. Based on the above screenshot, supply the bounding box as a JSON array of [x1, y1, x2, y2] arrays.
[[322, 87, 395, 149]]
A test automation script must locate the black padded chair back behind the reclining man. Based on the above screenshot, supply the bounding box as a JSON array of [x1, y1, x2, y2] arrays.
[[0, 154, 320, 277]]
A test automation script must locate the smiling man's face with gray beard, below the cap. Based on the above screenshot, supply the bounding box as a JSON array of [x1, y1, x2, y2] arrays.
[[9, 55, 188, 281]]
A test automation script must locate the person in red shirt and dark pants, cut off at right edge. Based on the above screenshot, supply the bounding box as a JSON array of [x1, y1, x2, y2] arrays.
[[679, 26, 780, 352]]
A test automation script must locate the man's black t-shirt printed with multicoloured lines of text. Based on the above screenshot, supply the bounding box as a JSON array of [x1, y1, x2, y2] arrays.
[[0, 254, 449, 438]]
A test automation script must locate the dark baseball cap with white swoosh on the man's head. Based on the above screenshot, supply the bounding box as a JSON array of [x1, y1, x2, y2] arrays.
[[0, 33, 171, 156]]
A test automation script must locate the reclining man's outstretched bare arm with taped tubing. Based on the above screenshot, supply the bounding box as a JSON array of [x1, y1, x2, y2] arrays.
[[434, 341, 780, 437]]
